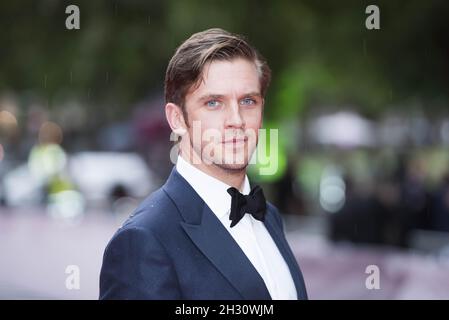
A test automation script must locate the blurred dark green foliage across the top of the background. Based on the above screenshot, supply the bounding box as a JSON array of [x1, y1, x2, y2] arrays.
[[0, 0, 449, 123]]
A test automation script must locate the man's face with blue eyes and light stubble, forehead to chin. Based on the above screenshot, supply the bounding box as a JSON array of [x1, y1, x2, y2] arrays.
[[181, 59, 263, 170]]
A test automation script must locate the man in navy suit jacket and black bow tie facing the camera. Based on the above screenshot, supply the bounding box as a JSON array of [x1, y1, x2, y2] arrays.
[[100, 29, 307, 300]]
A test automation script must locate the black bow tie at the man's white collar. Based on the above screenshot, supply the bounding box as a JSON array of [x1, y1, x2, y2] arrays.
[[228, 186, 267, 228]]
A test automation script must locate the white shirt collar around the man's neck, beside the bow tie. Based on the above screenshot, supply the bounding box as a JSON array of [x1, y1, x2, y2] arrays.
[[176, 155, 251, 218]]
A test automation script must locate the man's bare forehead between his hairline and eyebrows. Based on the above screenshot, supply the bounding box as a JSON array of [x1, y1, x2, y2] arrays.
[[189, 58, 260, 96]]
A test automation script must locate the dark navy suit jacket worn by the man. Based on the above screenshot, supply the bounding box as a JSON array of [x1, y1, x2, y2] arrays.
[[100, 168, 307, 300]]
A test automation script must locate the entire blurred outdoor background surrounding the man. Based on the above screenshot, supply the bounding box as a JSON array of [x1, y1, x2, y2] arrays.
[[0, 0, 449, 299]]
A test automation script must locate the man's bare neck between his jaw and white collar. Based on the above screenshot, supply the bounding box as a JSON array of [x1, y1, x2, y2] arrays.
[[181, 152, 246, 192]]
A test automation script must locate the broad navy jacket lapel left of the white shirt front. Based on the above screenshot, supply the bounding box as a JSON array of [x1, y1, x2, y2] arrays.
[[163, 168, 271, 300]]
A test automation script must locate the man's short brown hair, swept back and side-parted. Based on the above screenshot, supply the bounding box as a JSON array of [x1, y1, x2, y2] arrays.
[[165, 28, 271, 121]]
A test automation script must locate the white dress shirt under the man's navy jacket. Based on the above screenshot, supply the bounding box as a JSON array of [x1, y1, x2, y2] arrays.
[[176, 156, 297, 300]]
